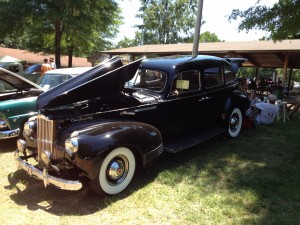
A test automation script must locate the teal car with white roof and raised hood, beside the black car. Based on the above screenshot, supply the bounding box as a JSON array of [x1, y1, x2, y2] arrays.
[[0, 67, 92, 140]]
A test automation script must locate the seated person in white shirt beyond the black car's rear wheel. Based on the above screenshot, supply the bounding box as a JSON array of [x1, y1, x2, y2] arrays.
[[253, 94, 279, 125]]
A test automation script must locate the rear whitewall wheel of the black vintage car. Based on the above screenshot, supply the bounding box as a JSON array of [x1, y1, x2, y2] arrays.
[[227, 108, 243, 138]]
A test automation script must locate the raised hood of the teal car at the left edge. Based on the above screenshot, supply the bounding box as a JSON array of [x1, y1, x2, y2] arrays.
[[0, 67, 42, 91]]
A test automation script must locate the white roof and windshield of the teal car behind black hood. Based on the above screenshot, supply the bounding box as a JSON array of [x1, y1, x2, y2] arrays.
[[36, 67, 93, 91]]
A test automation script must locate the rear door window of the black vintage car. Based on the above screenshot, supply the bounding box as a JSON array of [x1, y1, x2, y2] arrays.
[[203, 67, 223, 88]]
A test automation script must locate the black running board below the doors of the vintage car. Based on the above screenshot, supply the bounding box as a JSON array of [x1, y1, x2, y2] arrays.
[[164, 127, 225, 153]]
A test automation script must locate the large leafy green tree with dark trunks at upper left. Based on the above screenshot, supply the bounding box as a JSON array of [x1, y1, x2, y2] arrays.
[[0, 0, 121, 67]]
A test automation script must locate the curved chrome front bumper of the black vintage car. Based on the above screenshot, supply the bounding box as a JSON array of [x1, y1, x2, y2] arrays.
[[14, 149, 82, 191]]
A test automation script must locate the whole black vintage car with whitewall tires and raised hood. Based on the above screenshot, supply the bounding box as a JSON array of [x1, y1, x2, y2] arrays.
[[15, 56, 249, 195]]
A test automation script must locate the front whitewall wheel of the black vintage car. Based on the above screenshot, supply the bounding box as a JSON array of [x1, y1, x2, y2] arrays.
[[91, 147, 136, 195]]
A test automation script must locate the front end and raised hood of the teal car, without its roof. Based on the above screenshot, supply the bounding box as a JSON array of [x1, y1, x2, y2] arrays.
[[0, 68, 43, 140]]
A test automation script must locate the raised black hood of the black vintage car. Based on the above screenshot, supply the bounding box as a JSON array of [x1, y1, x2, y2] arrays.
[[37, 58, 141, 109]]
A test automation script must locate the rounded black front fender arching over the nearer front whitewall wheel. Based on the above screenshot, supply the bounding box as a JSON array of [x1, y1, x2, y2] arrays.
[[68, 121, 162, 179]]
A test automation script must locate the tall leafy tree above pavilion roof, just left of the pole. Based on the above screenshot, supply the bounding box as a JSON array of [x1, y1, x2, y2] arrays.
[[137, 0, 198, 45]]
